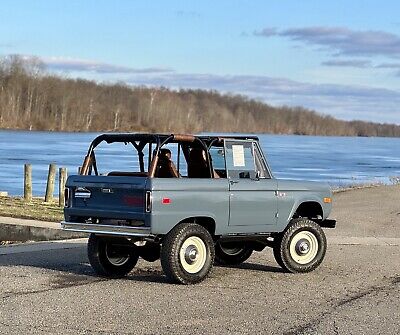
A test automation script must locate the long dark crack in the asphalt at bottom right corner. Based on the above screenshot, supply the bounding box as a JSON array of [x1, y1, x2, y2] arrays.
[[283, 276, 400, 335]]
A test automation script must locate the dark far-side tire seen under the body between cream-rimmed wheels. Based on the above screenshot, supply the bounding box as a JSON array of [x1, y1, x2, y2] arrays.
[[215, 242, 253, 265]]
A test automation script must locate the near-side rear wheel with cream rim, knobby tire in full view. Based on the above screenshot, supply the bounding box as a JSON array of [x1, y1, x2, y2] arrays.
[[161, 223, 215, 284]]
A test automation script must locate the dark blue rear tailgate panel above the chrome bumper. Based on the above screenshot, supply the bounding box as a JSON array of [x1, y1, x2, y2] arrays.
[[65, 175, 148, 221]]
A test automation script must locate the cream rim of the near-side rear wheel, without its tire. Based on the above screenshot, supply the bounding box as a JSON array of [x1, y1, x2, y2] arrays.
[[179, 236, 207, 273]]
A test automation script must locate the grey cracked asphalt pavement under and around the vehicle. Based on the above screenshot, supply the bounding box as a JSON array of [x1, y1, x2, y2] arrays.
[[0, 188, 400, 334]]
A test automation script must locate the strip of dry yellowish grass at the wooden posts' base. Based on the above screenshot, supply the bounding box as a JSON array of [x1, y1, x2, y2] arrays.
[[0, 197, 63, 222]]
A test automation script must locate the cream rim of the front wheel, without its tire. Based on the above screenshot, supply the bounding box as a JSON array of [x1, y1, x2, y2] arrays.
[[289, 230, 319, 265]]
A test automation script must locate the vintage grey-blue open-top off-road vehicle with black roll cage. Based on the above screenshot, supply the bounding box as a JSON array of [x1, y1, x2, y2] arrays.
[[61, 134, 336, 284]]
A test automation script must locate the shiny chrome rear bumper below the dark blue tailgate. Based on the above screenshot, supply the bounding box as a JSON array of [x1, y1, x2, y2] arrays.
[[61, 221, 153, 237]]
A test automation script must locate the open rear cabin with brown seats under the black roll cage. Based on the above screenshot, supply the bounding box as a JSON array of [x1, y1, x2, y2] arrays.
[[80, 134, 264, 179]]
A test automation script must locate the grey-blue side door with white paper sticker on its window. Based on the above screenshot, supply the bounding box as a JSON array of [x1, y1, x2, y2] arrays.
[[225, 140, 278, 231]]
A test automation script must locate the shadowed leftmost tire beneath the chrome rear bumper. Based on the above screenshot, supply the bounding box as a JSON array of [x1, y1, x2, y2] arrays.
[[87, 234, 139, 278]]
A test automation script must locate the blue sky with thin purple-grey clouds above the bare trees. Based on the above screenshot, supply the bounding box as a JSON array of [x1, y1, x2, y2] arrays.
[[0, 0, 400, 124]]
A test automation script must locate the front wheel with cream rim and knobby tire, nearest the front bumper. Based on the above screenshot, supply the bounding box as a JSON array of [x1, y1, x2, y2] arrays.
[[273, 218, 327, 273]]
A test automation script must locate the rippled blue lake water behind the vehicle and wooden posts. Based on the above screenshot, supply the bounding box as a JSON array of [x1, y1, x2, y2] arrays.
[[0, 131, 400, 196]]
